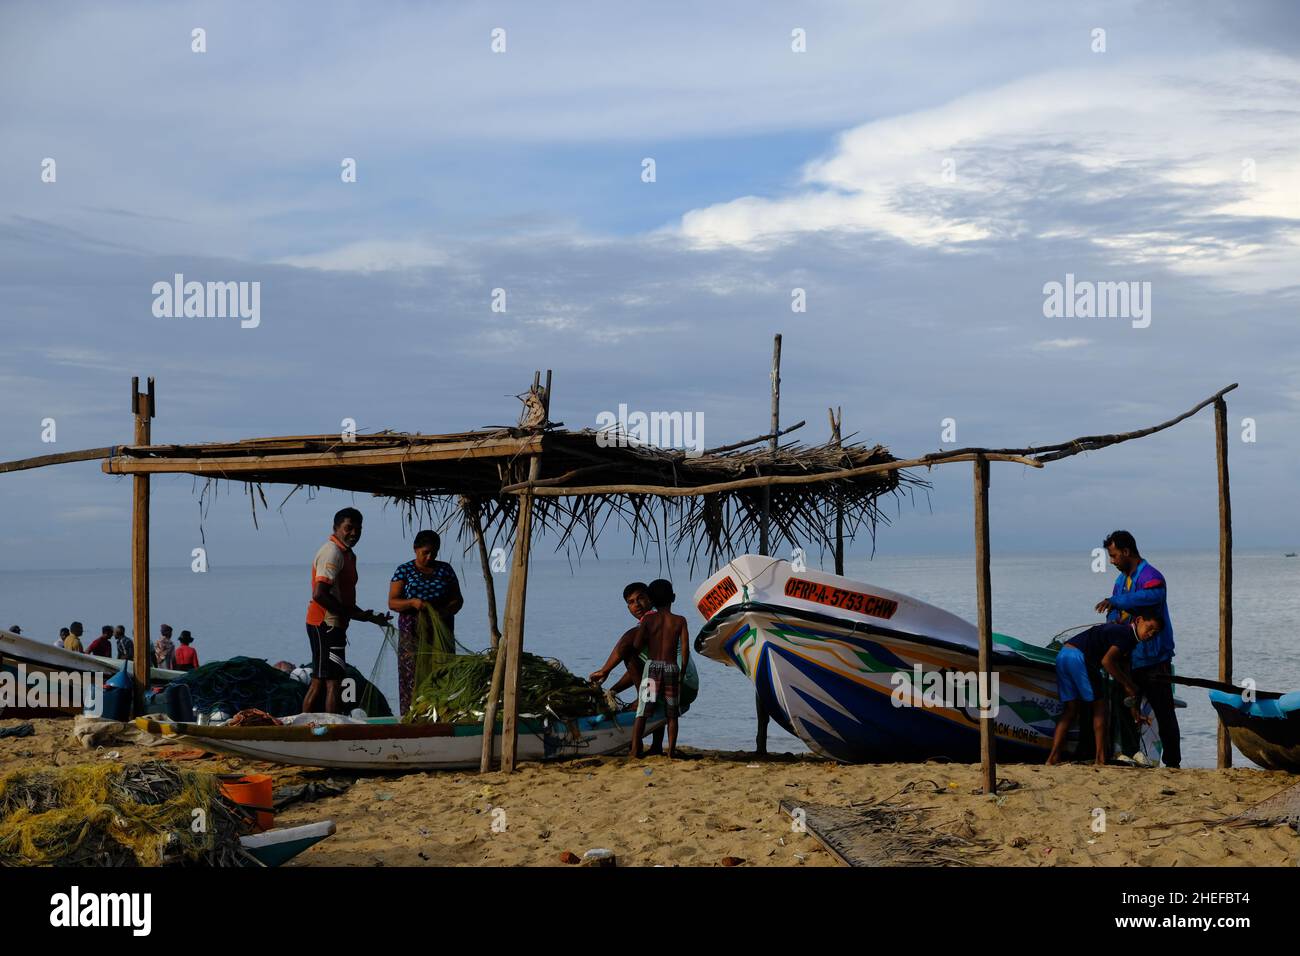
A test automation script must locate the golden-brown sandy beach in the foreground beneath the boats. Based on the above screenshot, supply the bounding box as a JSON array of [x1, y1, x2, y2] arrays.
[[0, 719, 1300, 866]]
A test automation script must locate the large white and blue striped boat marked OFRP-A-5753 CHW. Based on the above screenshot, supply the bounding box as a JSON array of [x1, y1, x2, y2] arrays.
[[694, 554, 1158, 763]]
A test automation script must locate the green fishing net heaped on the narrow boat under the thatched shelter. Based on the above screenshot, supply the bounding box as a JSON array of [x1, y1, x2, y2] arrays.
[[403, 609, 612, 723]]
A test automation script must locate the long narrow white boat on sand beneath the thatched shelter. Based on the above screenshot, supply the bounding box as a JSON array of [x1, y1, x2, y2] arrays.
[[135, 711, 663, 770]]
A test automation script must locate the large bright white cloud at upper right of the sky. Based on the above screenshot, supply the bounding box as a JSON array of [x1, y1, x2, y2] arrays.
[[679, 55, 1300, 287]]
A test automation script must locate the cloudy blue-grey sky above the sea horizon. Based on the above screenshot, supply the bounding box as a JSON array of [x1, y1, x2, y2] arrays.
[[0, 0, 1300, 570]]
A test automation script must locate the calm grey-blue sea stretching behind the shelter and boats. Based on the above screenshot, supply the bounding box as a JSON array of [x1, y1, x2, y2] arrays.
[[0, 548, 1300, 766]]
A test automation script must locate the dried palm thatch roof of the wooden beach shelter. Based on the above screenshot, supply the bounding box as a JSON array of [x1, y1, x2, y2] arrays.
[[104, 415, 928, 570]]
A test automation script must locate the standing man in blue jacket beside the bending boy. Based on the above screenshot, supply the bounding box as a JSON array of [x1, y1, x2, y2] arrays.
[[1097, 531, 1183, 767]]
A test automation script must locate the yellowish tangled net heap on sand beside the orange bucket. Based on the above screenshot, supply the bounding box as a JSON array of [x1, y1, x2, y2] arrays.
[[0, 761, 260, 866]]
